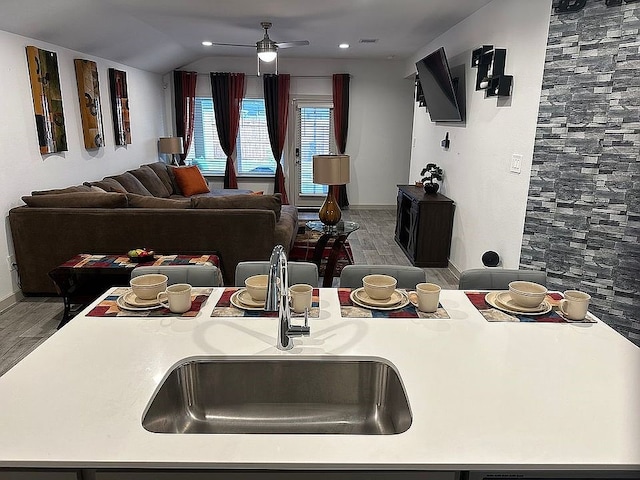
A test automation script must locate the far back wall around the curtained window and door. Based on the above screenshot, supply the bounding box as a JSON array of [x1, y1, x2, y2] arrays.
[[172, 55, 413, 206]]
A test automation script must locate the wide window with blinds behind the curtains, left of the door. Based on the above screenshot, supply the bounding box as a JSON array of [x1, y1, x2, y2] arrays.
[[187, 97, 276, 176]]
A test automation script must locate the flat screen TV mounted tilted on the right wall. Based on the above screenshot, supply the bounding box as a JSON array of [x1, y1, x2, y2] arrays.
[[416, 47, 464, 122]]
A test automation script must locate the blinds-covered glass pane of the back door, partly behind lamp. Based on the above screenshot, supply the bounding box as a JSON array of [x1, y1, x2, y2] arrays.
[[297, 105, 336, 195]]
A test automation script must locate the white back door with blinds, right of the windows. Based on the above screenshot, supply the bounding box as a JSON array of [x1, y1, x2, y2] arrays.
[[289, 100, 336, 207]]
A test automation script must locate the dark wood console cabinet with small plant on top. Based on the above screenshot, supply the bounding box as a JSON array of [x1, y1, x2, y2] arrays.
[[395, 185, 454, 268]]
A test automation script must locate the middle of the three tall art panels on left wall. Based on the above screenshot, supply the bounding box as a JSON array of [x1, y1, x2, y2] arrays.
[[74, 58, 104, 149]]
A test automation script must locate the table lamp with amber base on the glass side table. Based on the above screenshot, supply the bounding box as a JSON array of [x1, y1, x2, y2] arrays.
[[313, 155, 350, 226]]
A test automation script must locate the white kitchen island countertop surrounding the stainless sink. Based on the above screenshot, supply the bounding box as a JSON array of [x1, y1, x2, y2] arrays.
[[0, 289, 640, 470]]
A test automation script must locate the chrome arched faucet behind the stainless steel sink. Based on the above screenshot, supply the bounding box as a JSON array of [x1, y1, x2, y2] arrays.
[[264, 245, 310, 350]]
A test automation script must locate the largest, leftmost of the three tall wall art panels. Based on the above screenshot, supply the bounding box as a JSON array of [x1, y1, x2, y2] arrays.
[[27, 46, 67, 154]]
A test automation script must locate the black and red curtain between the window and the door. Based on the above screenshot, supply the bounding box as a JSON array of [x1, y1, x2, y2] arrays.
[[263, 73, 291, 205]]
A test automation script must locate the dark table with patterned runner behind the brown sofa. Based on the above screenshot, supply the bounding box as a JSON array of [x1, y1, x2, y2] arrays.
[[49, 253, 221, 328]]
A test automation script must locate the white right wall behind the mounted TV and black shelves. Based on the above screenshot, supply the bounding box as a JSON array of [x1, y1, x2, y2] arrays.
[[406, 0, 551, 271]]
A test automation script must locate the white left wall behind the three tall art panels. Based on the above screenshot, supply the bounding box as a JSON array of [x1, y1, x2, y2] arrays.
[[0, 31, 164, 302]]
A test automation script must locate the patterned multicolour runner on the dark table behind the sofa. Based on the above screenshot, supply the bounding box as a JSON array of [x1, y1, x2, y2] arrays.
[[59, 253, 220, 269]]
